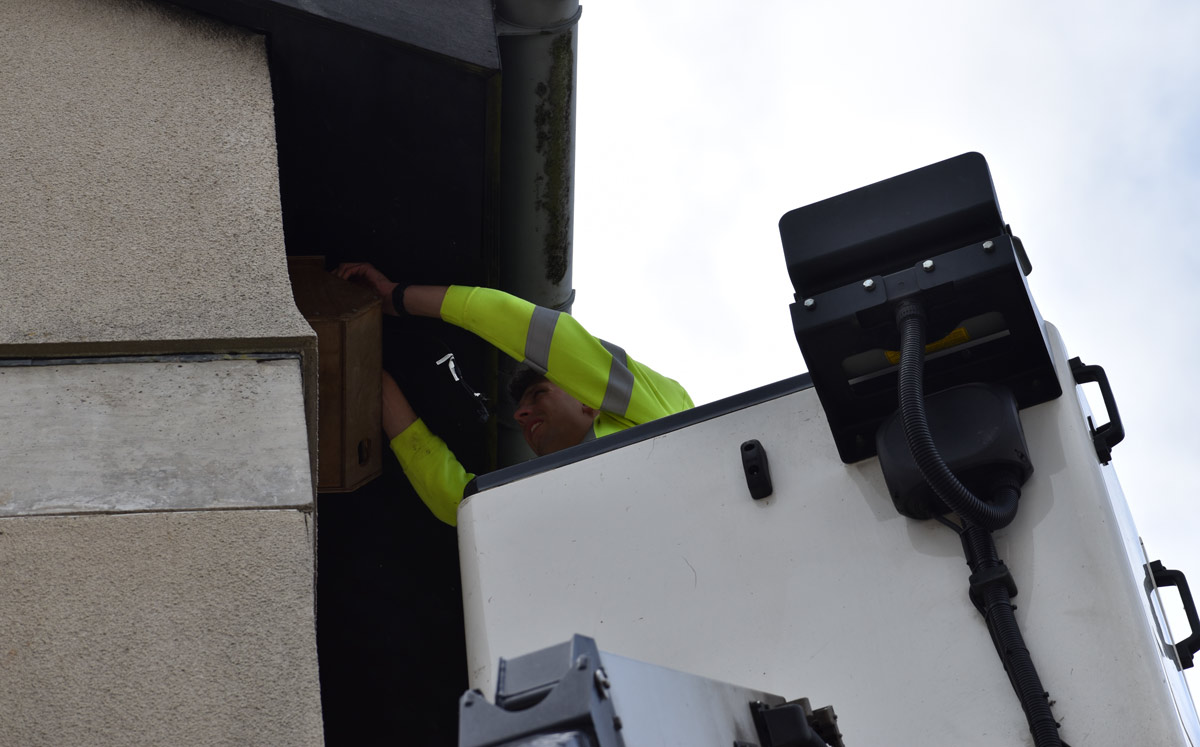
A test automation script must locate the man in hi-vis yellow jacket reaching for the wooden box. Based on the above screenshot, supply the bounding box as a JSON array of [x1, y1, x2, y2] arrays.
[[335, 263, 692, 525]]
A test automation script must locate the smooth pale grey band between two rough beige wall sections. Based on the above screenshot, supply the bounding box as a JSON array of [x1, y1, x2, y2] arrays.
[[0, 358, 312, 516]]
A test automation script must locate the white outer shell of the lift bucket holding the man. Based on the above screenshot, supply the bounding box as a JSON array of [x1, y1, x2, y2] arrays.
[[458, 327, 1188, 747]]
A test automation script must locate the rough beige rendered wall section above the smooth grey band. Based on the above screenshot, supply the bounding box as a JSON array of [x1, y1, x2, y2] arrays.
[[0, 0, 312, 357]]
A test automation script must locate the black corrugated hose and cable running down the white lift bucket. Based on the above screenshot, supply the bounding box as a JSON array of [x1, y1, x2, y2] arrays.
[[895, 300, 1063, 747]]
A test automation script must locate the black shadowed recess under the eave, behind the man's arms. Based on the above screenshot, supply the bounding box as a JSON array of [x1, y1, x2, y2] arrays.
[[163, 0, 500, 746]]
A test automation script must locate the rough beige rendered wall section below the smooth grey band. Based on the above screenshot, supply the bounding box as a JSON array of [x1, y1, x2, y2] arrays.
[[0, 510, 322, 747]]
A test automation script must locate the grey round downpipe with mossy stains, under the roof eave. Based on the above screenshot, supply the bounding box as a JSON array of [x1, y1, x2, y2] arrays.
[[496, 0, 583, 466]]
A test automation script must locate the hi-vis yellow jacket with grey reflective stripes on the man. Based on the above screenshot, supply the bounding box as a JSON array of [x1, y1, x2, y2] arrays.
[[391, 286, 692, 526]]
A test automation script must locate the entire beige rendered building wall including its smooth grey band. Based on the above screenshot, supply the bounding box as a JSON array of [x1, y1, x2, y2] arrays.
[[0, 0, 323, 746]]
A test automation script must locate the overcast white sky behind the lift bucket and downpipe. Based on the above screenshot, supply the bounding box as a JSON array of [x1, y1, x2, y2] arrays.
[[574, 0, 1200, 715]]
